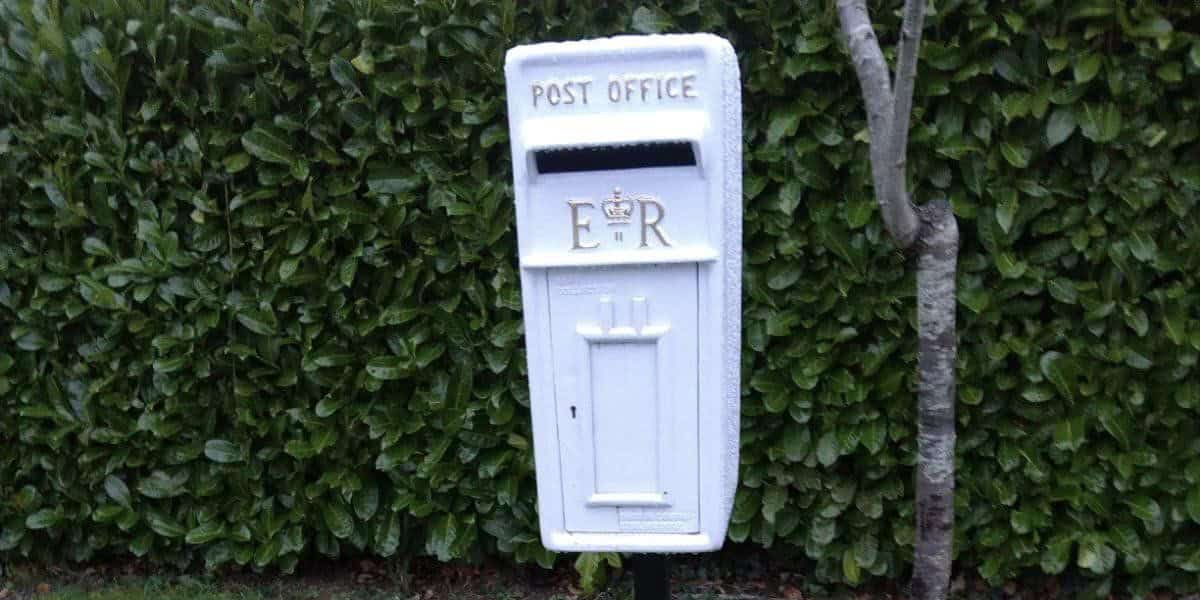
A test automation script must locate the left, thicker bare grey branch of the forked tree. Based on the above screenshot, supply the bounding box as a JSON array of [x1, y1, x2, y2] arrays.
[[838, 0, 919, 248]]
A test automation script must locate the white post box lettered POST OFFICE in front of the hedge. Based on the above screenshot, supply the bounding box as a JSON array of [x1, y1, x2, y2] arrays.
[[504, 35, 742, 552]]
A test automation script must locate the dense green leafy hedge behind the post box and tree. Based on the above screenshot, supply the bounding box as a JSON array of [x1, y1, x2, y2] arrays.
[[0, 0, 1200, 592]]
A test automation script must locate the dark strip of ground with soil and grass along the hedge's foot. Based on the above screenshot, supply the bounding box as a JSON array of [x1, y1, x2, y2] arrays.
[[0, 548, 1200, 600]]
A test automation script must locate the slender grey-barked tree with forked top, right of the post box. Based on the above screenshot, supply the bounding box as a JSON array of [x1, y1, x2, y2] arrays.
[[838, 0, 959, 600]]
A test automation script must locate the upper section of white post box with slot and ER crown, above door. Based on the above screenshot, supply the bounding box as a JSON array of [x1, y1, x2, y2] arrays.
[[504, 34, 742, 269]]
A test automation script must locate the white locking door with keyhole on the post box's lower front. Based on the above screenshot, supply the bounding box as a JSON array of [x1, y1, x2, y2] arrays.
[[546, 263, 700, 533]]
